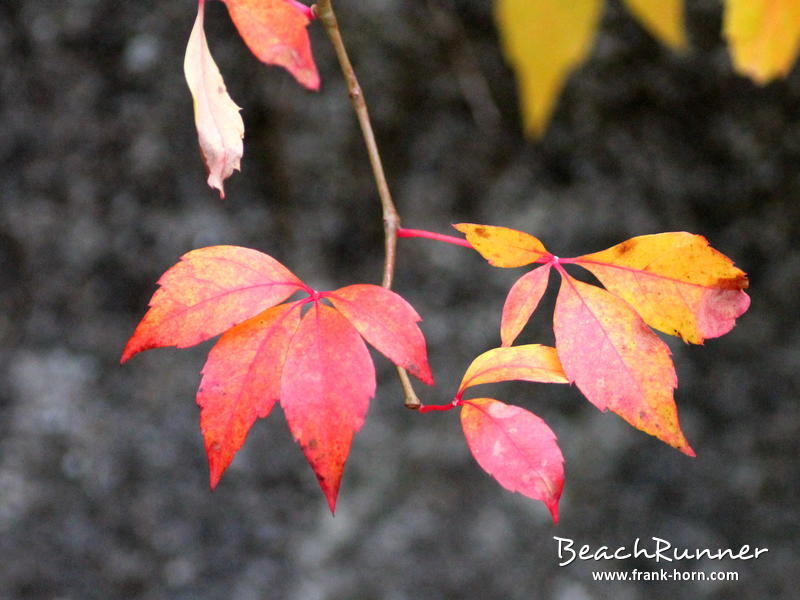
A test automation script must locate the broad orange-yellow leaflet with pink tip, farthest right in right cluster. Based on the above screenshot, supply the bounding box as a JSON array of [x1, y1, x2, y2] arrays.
[[576, 232, 750, 344]]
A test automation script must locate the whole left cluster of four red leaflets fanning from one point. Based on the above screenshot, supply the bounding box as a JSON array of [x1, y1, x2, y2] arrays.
[[122, 246, 433, 512]]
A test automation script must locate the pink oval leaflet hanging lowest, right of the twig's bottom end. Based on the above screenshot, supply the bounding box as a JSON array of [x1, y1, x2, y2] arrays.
[[461, 398, 564, 522]]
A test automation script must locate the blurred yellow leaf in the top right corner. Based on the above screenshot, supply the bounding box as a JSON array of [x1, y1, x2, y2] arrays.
[[724, 0, 800, 85]]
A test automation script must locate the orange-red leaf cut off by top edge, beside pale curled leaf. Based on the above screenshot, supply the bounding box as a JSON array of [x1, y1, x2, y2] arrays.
[[225, 0, 319, 90]]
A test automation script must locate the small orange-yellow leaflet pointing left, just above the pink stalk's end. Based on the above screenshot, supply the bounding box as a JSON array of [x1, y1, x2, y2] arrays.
[[453, 223, 550, 268]]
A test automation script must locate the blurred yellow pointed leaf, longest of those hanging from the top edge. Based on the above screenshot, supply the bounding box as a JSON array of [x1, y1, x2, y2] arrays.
[[495, 0, 603, 137]]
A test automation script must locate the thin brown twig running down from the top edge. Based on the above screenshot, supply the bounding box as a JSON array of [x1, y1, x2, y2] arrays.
[[312, 0, 421, 410]]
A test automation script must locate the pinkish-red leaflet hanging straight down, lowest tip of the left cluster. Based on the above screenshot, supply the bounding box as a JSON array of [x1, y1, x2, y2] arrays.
[[281, 302, 375, 512]]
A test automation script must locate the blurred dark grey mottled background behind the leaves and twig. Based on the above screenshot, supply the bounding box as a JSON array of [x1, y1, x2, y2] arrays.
[[0, 0, 800, 600]]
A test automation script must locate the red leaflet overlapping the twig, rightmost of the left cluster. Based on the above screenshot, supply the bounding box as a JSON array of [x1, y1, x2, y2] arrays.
[[323, 284, 433, 385]]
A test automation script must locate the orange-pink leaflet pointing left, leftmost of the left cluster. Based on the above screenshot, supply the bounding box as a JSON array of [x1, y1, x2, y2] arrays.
[[121, 246, 305, 362]]
